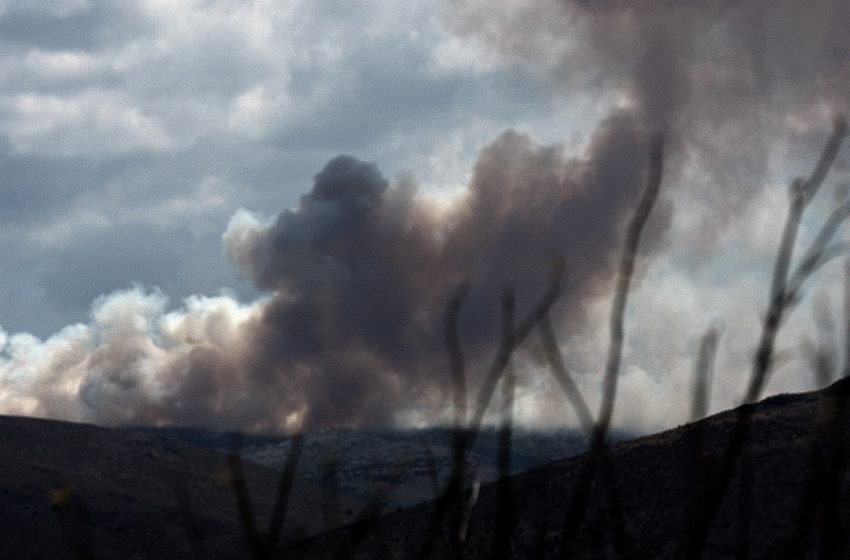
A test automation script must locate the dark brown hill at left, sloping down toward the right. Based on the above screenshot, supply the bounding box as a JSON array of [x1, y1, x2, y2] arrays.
[[0, 416, 364, 560]]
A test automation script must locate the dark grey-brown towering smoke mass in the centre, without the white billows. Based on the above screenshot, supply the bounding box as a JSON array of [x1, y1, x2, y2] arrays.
[[215, 113, 663, 426]]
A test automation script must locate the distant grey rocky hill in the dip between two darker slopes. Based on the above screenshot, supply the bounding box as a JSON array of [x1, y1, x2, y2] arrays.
[[132, 428, 608, 510]]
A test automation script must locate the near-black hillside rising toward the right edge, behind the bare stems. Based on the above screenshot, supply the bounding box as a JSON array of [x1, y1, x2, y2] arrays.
[[282, 379, 850, 559]]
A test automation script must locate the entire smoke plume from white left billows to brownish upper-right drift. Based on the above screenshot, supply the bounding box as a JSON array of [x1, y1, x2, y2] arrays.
[[0, 0, 850, 430]]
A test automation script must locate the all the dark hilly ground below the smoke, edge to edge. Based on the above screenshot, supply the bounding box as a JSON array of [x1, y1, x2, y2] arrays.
[[6, 379, 850, 559]]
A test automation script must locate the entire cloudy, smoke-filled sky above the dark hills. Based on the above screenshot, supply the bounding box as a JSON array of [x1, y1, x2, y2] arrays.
[[0, 0, 850, 431]]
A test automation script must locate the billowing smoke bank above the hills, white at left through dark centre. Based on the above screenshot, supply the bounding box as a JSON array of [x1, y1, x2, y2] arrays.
[[0, 113, 663, 430]]
